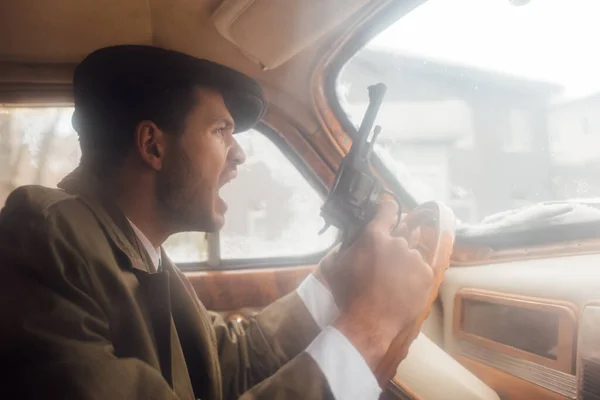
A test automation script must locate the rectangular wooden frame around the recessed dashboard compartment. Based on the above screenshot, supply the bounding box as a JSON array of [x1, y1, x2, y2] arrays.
[[452, 289, 579, 374]]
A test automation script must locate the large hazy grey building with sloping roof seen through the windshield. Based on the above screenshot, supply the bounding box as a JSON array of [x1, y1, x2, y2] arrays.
[[339, 48, 561, 222]]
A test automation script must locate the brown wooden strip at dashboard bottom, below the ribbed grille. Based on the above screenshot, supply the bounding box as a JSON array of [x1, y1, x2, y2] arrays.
[[455, 356, 571, 400]]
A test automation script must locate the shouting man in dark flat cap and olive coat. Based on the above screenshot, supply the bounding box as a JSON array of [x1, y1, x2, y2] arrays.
[[0, 46, 432, 400]]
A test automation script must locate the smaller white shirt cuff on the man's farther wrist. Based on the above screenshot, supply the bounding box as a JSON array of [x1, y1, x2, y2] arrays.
[[296, 274, 340, 330]]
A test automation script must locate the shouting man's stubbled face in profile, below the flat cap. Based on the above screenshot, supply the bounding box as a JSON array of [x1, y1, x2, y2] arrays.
[[157, 89, 246, 232]]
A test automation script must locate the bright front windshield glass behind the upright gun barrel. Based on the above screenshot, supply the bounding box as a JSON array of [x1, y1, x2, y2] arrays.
[[336, 0, 600, 223]]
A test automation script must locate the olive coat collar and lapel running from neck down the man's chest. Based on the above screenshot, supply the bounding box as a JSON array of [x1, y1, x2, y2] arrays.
[[58, 166, 222, 400]]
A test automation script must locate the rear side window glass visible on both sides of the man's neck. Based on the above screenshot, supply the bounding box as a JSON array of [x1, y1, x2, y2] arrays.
[[0, 107, 208, 263]]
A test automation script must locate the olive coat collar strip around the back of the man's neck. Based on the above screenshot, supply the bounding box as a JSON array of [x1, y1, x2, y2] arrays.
[[57, 165, 157, 273]]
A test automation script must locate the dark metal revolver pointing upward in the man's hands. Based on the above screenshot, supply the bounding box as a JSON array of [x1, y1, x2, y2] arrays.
[[319, 83, 400, 248]]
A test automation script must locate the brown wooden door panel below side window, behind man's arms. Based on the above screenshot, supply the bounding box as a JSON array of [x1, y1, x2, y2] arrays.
[[185, 265, 315, 311]]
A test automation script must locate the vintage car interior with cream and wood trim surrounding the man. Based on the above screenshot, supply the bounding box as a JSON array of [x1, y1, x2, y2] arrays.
[[0, 0, 600, 400]]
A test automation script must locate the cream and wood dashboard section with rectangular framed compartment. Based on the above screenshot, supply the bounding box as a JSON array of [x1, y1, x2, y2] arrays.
[[440, 255, 600, 400]]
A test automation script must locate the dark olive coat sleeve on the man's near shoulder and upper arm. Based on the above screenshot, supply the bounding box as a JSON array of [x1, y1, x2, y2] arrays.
[[0, 200, 177, 400]]
